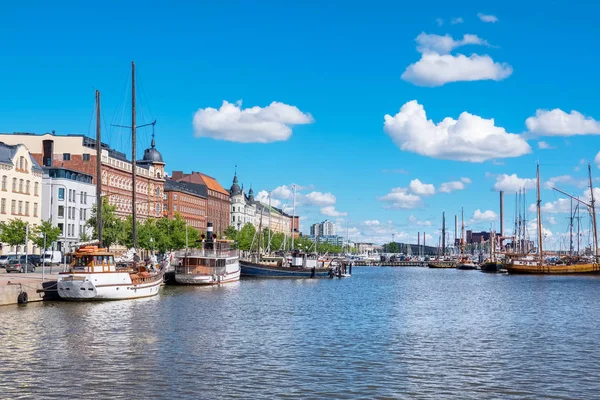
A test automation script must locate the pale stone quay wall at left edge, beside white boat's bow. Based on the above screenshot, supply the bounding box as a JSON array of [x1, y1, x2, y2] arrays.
[[0, 268, 58, 306]]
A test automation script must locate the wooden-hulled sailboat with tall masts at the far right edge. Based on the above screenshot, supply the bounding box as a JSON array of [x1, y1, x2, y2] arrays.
[[504, 164, 600, 275]]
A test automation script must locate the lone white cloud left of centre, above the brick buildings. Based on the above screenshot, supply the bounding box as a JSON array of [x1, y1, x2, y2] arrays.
[[193, 101, 314, 143]]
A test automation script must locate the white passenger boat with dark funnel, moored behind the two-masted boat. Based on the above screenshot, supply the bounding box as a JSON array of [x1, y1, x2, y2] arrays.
[[175, 222, 240, 285]]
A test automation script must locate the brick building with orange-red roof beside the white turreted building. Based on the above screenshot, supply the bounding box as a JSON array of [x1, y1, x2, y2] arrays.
[[171, 171, 230, 234]]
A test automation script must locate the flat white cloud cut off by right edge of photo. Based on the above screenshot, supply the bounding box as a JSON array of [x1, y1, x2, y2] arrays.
[[525, 108, 600, 136]]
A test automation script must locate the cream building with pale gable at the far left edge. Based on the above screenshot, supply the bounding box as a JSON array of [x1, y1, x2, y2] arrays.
[[0, 143, 43, 253]]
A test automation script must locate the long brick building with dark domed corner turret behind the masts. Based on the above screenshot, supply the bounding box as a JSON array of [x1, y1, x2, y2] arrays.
[[0, 133, 165, 220]]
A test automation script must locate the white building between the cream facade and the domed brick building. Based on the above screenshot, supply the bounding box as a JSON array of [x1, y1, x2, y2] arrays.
[[42, 167, 96, 252]]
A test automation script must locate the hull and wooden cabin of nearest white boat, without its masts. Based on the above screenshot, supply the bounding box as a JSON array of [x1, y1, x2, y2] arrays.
[[57, 246, 163, 300]]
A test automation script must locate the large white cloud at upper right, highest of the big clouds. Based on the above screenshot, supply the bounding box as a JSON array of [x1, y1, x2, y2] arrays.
[[402, 53, 513, 87]]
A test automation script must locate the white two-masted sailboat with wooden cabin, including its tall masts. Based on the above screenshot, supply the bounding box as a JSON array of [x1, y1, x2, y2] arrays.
[[57, 62, 164, 300]]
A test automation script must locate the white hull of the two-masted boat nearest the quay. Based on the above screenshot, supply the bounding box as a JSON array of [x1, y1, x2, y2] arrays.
[[56, 272, 163, 301]]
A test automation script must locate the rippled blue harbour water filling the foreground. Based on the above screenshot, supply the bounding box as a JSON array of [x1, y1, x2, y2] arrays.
[[0, 267, 600, 399]]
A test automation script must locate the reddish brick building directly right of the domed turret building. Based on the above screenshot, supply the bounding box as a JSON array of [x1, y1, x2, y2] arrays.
[[164, 179, 208, 233]]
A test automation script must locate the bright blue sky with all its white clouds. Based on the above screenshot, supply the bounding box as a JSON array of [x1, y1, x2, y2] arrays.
[[0, 0, 600, 248]]
